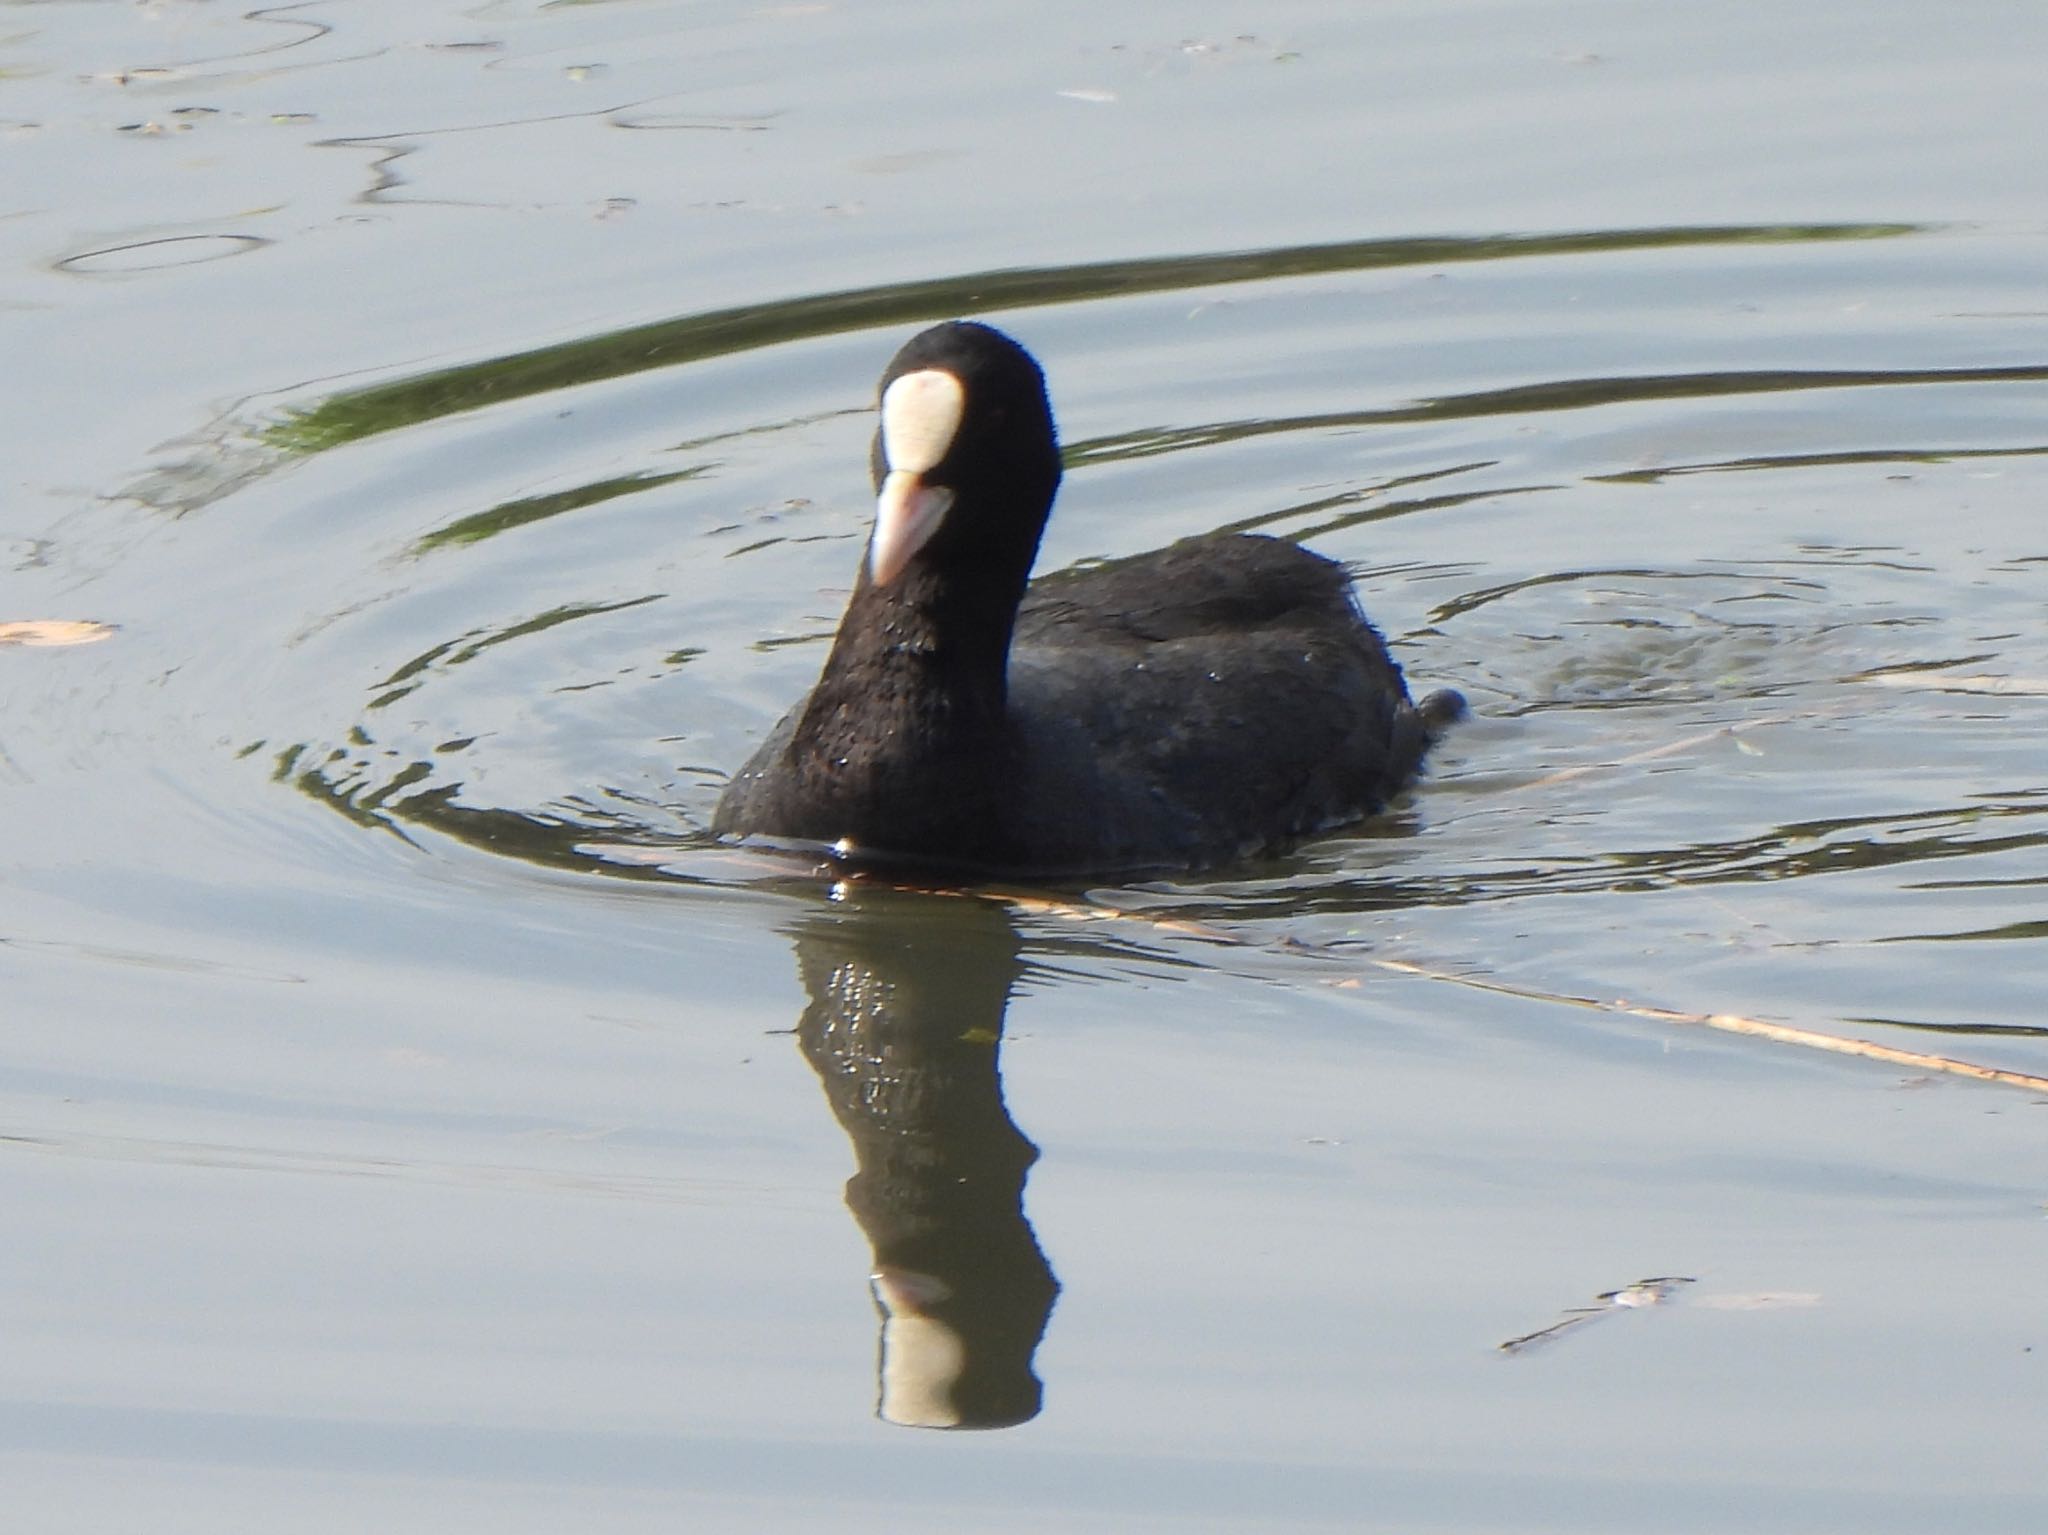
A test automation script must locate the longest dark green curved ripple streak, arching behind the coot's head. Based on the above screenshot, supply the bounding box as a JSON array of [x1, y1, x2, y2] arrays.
[[266, 223, 1923, 452]]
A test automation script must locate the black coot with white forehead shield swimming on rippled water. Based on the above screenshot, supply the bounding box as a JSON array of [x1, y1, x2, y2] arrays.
[[713, 321, 1464, 876]]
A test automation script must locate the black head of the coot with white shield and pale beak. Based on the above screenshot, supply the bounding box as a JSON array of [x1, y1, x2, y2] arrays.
[[864, 319, 1059, 593]]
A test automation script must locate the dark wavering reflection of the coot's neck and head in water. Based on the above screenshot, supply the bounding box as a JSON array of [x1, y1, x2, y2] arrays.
[[795, 884, 1059, 1429]]
